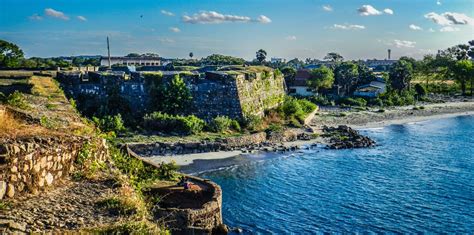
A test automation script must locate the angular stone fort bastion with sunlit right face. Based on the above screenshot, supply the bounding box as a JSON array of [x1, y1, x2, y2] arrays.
[[57, 66, 285, 120]]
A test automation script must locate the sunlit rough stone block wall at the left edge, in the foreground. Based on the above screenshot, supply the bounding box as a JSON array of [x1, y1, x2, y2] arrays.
[[0, 136, 108, 199]]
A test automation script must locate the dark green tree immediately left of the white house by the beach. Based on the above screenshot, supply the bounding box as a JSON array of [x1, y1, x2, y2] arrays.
[[334, 62, 359, 96]]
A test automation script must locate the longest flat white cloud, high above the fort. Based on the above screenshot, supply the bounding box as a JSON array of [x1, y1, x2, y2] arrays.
[[182, 11, 272, 24]]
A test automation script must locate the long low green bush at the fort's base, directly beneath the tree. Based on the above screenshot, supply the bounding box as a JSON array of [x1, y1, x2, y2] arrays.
[[143, 112, 206, 135]]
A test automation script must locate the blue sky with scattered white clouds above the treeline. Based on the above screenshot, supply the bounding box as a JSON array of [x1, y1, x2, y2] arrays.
[[0, 0, 474, 60]]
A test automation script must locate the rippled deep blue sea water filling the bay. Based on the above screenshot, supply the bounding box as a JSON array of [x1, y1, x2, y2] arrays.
[[200, 116, 474, 234]]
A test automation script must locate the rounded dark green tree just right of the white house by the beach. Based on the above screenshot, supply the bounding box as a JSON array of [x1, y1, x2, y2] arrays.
[[389, 60, 413, 93]]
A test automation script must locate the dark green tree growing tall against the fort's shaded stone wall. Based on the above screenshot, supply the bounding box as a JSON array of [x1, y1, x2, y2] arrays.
[[164, 75, 192, 114]]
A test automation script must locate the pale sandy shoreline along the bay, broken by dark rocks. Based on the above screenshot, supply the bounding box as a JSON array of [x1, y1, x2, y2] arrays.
[[146, 102, 474, 174]]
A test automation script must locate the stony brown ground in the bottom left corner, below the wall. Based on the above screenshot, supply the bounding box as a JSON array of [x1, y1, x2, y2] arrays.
[[0, 180, 120, 233]]
